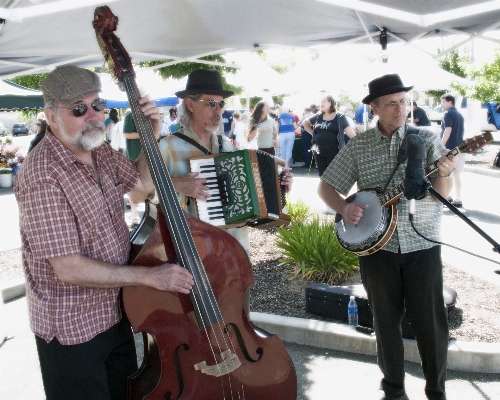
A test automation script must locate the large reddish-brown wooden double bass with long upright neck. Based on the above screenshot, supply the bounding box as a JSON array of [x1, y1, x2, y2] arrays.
[[93, 6, 297, 400]]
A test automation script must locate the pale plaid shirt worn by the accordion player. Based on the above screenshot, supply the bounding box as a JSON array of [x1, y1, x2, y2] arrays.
[[162, 127, 250, 252]]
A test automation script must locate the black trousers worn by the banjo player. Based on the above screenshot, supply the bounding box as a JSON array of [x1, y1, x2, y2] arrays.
[[359, 246, 448, 400]]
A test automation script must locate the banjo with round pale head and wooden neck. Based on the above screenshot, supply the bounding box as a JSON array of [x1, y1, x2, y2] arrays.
[[335, 132, 493, 256]]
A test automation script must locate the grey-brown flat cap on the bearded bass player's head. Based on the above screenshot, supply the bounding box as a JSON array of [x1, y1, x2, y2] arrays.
[[41, 65, 101, 104]]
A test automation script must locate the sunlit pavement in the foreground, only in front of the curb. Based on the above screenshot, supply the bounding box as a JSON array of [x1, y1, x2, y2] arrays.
[[0, 297, 500, 400]]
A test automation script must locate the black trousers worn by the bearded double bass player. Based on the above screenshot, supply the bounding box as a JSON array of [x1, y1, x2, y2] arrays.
[[35, 319, 137, 400]]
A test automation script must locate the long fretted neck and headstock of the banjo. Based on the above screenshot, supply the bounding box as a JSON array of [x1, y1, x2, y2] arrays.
[[377, 132, 493, 207]]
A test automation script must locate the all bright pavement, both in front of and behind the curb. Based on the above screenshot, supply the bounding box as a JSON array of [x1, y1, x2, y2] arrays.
[[0, 140, 500, 400]]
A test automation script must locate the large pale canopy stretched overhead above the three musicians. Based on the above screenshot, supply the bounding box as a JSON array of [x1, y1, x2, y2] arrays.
[[0, 0, 500, 79]]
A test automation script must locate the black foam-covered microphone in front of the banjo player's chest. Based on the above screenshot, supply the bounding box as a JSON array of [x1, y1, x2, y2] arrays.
[[403, 135, 430, 218]]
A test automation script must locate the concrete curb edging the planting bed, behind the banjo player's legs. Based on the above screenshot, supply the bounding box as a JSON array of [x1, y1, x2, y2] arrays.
[[250, 312, 500, 374]]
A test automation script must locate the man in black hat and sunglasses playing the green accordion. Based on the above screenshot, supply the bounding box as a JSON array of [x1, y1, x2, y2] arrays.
[[162, 69, 293, 316]]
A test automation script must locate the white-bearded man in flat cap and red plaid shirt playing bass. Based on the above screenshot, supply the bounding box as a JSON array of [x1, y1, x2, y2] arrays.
[[15, 66, 193, 400]]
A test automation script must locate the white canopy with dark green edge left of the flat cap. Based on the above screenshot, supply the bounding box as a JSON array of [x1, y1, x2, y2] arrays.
[[0, 81, 43, 111]]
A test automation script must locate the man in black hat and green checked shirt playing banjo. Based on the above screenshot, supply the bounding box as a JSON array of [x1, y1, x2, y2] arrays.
[[318, 74, 456, 400]]
